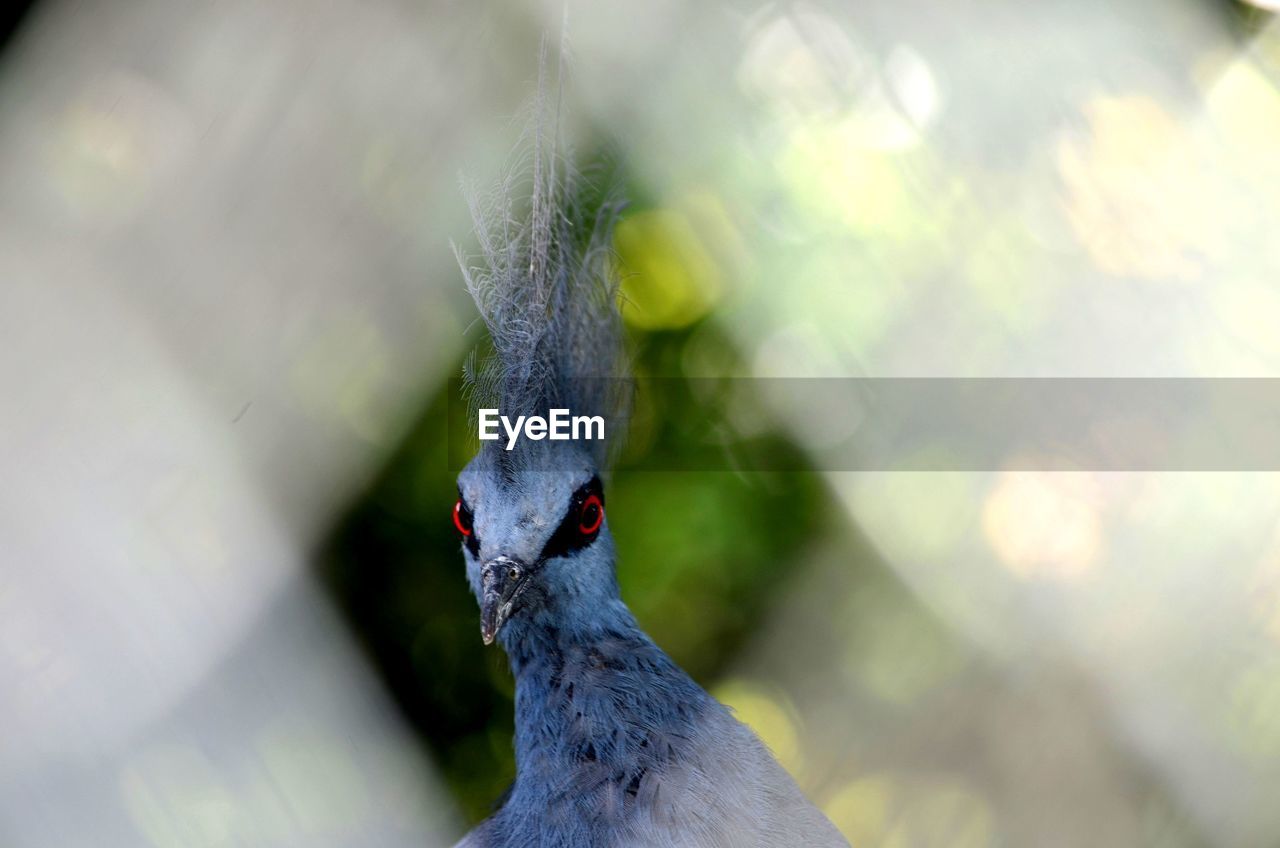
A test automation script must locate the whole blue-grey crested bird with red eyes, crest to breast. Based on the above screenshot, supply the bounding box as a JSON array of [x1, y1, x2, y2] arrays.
[[453, 41, 849, 848]]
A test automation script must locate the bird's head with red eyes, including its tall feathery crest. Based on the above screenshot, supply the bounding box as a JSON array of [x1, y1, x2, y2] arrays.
[[453, 81, 631, 648]]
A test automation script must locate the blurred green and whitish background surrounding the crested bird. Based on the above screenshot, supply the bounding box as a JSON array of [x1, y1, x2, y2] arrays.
[[0, 0, 1280, 848]]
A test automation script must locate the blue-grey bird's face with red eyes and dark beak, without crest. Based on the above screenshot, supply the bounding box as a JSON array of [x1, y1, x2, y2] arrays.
[[453, 451, 617, 644]]
